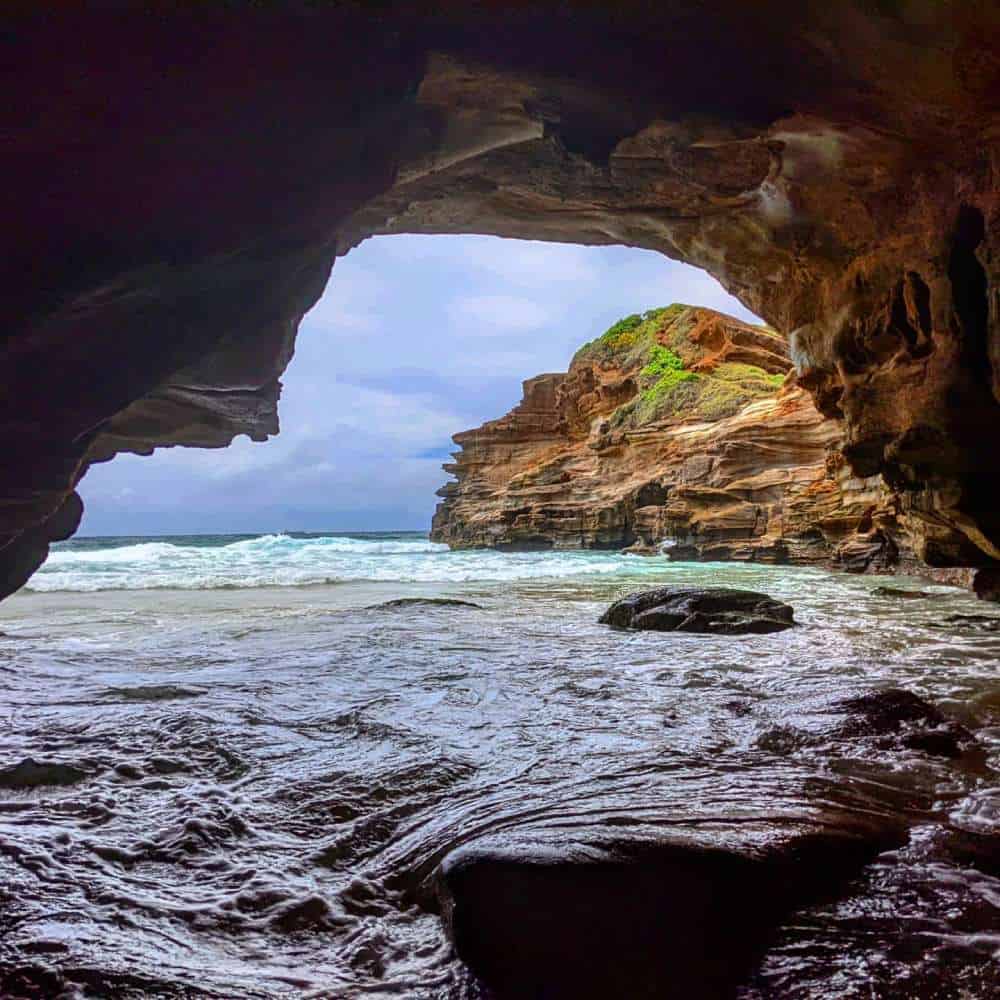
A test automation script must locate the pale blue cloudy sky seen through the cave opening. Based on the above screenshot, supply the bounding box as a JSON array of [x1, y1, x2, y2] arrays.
[[79, 236, 757, 535]]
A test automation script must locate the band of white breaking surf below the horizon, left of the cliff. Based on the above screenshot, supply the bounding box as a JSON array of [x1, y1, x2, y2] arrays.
[[29, 534, 665, 591]]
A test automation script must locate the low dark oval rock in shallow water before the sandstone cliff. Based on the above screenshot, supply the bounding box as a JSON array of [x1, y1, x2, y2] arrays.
[[599, 587, 795, 635]]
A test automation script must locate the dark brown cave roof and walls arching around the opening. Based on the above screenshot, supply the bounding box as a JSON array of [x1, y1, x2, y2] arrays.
[[0, 0, 1000, 592]]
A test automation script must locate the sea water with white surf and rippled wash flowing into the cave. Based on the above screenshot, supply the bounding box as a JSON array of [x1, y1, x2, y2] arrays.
[[0, 532, 1000, 1000]]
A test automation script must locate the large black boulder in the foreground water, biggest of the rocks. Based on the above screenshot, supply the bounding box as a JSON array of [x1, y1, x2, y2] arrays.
[[438, 816, 901, 1000]]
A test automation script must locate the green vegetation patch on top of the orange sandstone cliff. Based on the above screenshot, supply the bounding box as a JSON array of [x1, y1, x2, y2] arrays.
[[573, 304, 784, 428]]
